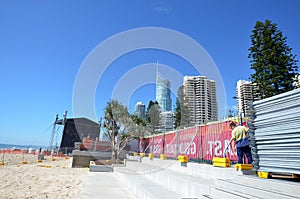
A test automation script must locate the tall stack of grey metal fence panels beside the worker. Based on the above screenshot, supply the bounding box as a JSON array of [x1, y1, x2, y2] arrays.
[[249, 89, 300, 174]]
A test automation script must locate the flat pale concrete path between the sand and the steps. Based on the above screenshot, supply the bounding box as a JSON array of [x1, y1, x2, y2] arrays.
[[82, 172, 136, 199]]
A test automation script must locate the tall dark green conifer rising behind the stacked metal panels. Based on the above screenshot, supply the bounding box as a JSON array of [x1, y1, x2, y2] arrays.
[[248, 20, 298, 99]]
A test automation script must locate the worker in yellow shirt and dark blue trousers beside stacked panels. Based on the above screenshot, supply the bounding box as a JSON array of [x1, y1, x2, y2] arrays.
[[230, 122, 252, 164]]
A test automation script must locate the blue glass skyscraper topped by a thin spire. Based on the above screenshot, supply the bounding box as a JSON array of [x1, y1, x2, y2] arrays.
[[156, 75, 172, 112]]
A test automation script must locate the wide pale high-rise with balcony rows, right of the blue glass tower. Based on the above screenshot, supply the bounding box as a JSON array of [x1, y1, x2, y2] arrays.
[[183, 76, 218, 126]]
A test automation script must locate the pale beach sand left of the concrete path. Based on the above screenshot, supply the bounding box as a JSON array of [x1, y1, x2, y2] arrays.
[[0, 154, 88, 199]]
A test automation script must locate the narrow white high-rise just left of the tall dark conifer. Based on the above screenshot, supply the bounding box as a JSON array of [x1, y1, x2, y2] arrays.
[[236, 80, 255, 117]]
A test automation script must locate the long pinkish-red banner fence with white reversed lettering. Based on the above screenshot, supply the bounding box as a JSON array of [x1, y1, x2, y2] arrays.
[[140, 121, 241, 163]]
